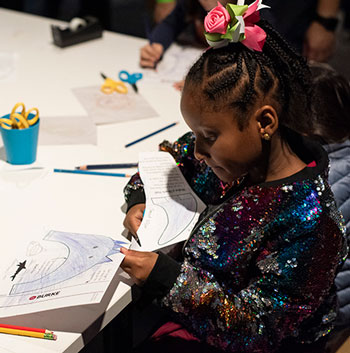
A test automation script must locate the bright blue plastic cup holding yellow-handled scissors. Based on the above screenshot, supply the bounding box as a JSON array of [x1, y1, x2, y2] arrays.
[[0, 114, 40, 164]]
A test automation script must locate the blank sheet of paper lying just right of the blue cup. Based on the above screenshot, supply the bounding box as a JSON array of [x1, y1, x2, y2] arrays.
[[39, 116, 97, 145]]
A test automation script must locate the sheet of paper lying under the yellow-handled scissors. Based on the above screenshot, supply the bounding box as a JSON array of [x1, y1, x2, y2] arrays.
[[73, 82, 158, 124]]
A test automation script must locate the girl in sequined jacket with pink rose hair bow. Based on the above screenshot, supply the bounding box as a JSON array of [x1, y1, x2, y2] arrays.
[[122, 0, 347, 353]]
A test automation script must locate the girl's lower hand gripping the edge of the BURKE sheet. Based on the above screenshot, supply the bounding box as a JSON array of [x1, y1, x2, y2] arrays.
[[120, 248, 158, 285]]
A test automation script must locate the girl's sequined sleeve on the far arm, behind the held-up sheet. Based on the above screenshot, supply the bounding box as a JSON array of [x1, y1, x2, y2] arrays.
[[124, 132, 231, 204]]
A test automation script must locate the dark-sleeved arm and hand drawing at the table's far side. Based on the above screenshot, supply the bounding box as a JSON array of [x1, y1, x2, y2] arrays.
[[140, 0, 186, 68]]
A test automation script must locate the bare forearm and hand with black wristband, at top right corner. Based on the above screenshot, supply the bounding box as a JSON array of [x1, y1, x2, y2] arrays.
[[303, 0, 340, 62]]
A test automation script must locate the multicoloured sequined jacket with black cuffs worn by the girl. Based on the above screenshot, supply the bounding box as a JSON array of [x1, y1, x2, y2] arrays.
[[125, 134, 347, 352]]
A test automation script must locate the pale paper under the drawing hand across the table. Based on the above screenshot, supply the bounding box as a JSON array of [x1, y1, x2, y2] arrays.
[[142, 44, 203, 83]]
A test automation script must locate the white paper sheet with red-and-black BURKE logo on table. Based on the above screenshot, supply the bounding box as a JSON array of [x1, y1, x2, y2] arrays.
[[0, 230, 130, 317]]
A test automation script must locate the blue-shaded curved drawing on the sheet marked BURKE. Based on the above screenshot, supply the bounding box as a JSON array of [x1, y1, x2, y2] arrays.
[[9, 231, 126, 295]]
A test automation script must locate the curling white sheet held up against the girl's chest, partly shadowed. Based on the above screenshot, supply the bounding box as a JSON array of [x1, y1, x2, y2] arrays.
[[132, 152, 206, 251]]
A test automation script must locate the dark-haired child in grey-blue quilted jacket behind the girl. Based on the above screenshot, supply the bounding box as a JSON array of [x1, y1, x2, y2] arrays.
[[310, 62, 350, 326]]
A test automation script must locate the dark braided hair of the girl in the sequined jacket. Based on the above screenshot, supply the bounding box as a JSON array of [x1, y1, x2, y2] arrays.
[[185, 20, 311, 133]]
